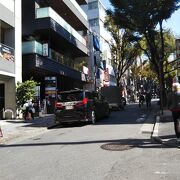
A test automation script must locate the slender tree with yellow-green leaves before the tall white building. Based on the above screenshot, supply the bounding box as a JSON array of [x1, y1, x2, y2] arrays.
[[104, 16, 140, 86]]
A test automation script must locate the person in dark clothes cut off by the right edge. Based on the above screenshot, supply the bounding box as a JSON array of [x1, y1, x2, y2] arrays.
[[167, 83, 180, 142]]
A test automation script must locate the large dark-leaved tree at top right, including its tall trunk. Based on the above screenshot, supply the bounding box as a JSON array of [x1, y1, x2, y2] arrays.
[[107, 0, 180, 108]]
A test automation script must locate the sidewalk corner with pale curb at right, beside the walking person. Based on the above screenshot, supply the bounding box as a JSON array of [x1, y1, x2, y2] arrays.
[[152, 109, 180, 148]]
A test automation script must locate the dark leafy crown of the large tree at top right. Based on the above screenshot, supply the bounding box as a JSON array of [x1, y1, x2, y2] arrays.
[[108, 0, 179, 34]]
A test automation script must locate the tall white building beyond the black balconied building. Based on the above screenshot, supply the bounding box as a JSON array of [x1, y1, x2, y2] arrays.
[[82, 0, 116, 90]]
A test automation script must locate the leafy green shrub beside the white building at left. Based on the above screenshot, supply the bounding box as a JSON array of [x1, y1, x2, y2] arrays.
[[16, 79, 39, 109]]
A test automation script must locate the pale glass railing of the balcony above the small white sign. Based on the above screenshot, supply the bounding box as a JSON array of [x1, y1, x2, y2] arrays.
[[36, 7, 86, 46]]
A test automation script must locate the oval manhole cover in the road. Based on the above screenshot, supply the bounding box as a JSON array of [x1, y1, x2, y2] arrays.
[[101, 143, 134, 151]]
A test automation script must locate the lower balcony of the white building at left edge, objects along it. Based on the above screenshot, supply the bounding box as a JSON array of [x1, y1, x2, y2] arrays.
[[0, 43, 15, 74]]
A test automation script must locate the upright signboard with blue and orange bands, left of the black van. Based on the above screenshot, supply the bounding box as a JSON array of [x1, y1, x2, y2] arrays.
[[45, 77, 57, 98]]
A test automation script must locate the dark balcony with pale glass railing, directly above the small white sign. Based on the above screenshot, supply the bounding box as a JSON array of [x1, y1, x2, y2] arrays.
[[36, 7, 89, 57]]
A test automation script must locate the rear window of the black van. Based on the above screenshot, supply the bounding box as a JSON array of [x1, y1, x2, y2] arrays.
[[58, 92, 83, 102]]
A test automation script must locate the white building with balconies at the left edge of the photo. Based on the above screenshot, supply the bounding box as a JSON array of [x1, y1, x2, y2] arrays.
[[0, 0, 22, 119]]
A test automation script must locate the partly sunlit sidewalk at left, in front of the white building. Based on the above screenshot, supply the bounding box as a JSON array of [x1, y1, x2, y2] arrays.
[[0, 114, 54, 144]]
